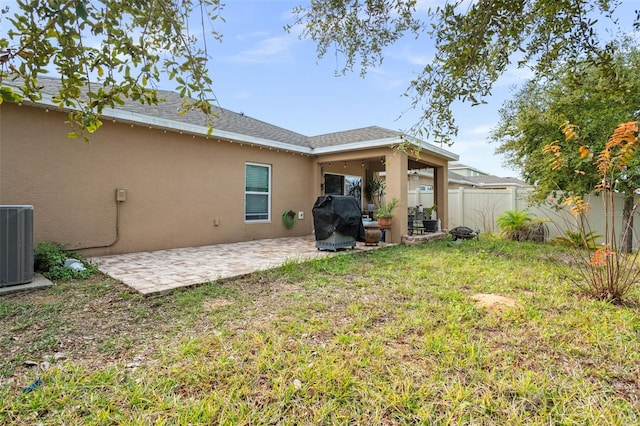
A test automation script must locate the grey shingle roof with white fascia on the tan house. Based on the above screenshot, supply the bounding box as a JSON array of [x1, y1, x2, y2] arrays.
[[2, 78, 458, 161]]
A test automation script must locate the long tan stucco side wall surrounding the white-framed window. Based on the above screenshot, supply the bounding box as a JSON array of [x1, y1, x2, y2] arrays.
[[0, 103, 317, 255]]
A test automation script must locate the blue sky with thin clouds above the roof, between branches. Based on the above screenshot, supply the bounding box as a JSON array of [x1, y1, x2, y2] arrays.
[[204, 0, 640, 176]]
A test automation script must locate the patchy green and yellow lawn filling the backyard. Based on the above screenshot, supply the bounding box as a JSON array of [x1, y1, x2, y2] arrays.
[[0, 238, 640, 425]]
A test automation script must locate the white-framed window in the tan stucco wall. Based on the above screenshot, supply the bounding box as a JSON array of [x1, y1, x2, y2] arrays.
[[244, 163, 271, 222]]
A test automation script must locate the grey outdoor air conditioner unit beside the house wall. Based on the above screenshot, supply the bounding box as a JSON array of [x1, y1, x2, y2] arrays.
[[0, 205, 33, 287]]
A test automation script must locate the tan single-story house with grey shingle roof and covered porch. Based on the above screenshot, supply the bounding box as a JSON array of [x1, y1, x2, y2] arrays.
[[0, 79, 458, 256]]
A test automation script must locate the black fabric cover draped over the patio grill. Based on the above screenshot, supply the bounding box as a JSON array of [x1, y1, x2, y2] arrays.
[[312, 195, 364, 242]]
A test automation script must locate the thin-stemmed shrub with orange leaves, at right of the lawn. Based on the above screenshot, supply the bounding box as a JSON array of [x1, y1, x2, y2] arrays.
[[543, 121, 640, 302]]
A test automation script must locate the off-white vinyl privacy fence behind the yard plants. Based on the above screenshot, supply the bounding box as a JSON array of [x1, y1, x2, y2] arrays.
[[408, 188, 640, 247]]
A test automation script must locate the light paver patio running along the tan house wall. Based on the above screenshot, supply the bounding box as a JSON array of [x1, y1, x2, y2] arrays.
[[90, 236, 384, 295]]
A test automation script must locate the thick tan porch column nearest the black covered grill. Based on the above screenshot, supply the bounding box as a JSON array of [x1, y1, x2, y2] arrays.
[[385, 150, 409, 244]]
